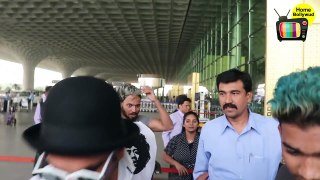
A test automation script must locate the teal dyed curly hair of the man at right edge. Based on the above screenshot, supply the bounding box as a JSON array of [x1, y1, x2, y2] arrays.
[[269, 67, 320, 128]]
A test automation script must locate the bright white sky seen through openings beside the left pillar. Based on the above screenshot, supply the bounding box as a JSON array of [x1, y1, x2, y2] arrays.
[[0, 59, 62, 89]]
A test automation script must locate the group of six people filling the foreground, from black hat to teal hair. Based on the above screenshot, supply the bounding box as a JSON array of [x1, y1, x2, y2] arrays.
[[23, 67, 320, 180]]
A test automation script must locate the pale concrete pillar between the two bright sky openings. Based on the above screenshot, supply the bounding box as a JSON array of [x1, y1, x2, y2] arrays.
[[22, 62, 36, 90]]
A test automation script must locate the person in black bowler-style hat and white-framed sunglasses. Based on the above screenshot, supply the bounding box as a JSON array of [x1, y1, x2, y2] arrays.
[[23, 77, 139, 180]]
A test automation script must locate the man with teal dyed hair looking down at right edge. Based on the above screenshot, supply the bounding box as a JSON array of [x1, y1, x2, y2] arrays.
[[269, 67, 320, 179]]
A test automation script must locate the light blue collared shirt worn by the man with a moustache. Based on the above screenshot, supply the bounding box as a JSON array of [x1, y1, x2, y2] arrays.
[[193, 112, 281, 180]]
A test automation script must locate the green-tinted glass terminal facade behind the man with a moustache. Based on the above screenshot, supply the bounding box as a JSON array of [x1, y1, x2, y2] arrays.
[[178, 0, 266, 114]]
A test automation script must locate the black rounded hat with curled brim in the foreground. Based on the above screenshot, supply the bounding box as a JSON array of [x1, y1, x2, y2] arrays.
[[23, 76, 139, 155]]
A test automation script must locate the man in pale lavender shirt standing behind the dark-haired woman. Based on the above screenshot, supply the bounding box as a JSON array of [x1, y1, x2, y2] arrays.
[[162, 94, 191, 147]]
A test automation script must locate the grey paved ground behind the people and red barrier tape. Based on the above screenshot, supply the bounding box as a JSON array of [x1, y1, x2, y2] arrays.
[[0, 110, 167, 180]]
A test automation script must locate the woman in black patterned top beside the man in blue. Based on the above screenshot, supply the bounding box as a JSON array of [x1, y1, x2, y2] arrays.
[[163, 111, 199, 180]]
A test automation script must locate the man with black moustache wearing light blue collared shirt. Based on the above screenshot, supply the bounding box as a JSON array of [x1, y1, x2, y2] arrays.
[[193, 69, 281, 180]]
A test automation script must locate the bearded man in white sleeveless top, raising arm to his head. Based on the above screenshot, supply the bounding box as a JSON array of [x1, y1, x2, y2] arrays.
[[116, 84, 173, 180]]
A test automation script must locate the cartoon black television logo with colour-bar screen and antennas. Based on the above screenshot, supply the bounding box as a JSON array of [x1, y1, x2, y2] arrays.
[[274, 9, 308, 42]]
